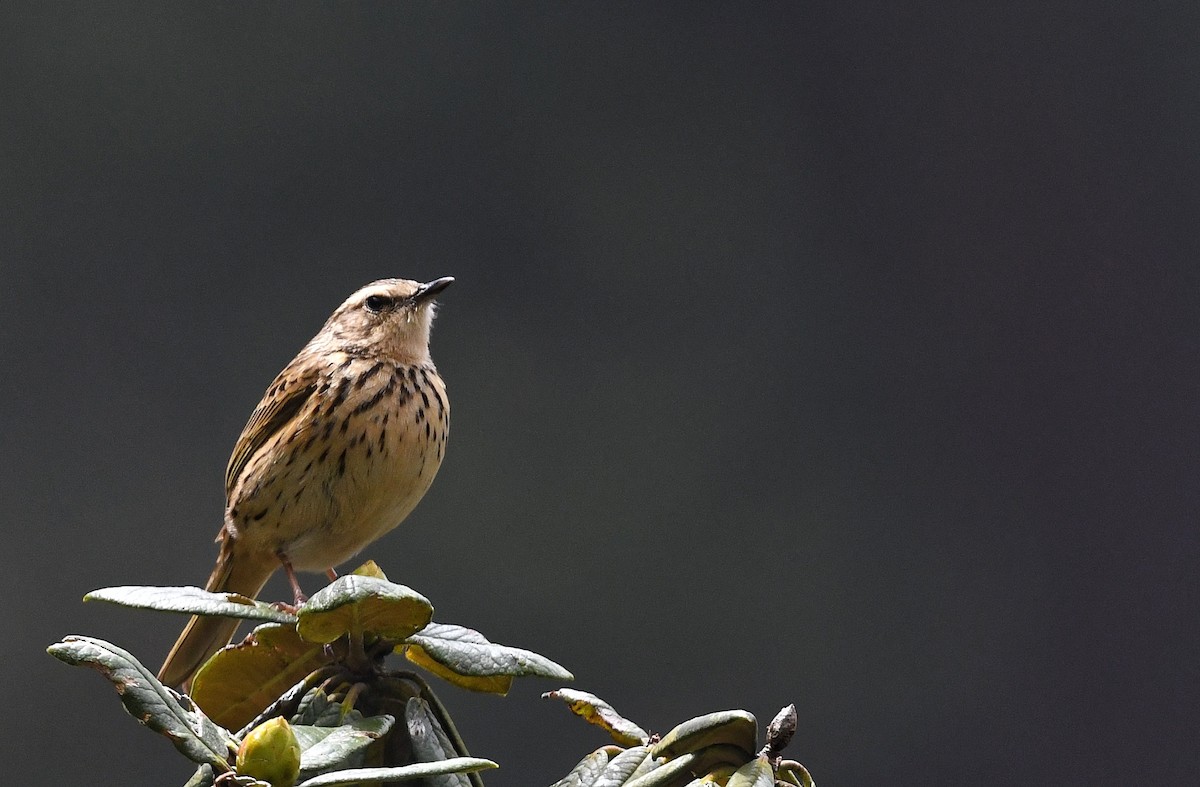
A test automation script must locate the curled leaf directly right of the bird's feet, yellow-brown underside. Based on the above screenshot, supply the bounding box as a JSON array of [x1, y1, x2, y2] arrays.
[[296, 573, 433, 643]]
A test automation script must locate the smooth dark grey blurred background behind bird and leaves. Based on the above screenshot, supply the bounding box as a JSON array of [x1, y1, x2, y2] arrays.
[[0, 2, 1200, 787]]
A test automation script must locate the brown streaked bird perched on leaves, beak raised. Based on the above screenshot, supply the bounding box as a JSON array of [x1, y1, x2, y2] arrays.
[[158, 277, 454, 686]]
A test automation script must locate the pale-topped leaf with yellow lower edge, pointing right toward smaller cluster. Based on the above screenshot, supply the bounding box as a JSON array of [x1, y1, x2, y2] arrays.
[[397, 623, 575, 693]]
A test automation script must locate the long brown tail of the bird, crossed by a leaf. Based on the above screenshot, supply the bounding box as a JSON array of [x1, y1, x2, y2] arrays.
[[158, 534, 280, 690]]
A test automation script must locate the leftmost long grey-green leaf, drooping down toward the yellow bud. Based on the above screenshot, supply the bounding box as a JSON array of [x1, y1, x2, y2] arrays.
[[47, 637, 238, 771]]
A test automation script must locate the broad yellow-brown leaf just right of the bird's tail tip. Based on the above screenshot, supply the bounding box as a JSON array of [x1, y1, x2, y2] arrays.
[[192, 624, 332, 729]]
